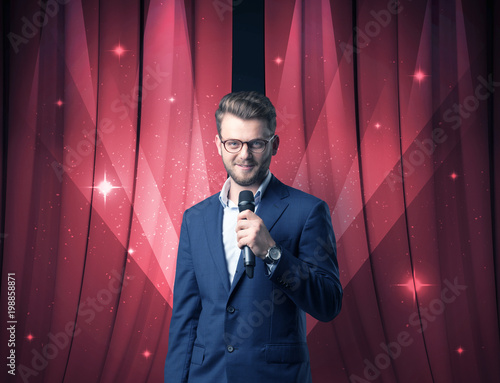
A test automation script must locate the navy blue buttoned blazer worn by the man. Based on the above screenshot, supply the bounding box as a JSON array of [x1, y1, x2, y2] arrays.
[[165, 176, 342, 383]]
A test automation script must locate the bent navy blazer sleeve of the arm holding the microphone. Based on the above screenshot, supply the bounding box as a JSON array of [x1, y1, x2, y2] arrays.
[[269, 200, 343, 322]]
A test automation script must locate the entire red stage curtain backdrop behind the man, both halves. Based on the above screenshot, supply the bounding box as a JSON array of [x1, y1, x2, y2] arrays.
[[0, 0, 500, 383]]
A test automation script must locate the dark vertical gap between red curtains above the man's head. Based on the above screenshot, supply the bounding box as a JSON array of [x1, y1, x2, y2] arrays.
[[232, 0, 266, 94]]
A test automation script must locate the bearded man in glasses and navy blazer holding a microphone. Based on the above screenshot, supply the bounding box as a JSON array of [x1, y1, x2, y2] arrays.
[[165, 92, 342, 383]]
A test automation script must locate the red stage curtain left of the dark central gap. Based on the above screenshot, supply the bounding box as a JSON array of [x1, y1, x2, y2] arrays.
[[2, 0, 231, 382]]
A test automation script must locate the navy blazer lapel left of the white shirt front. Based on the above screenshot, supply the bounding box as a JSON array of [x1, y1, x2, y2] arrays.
[[205, 196, 229, 293]]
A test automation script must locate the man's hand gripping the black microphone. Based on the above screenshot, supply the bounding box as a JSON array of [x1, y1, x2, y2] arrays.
[[236, 210, 276, 259]]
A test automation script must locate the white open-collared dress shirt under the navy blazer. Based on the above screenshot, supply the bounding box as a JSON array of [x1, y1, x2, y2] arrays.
[[219, 171, 274, 284]]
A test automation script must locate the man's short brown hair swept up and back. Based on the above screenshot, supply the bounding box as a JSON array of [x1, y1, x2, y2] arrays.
[[215, 91, 276, 136]]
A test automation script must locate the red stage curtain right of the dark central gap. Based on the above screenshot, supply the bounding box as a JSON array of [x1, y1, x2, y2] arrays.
[[266, 1, 500, 382]]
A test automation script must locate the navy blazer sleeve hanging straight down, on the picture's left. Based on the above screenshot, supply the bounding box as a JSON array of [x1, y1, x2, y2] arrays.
[[164, 211, 201, 383]]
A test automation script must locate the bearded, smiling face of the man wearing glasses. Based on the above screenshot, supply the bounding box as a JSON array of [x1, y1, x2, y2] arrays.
[[215, 113, 279, 187]]
